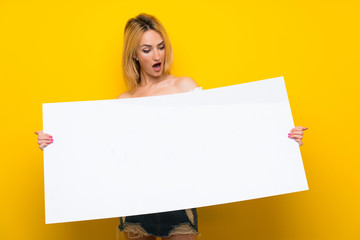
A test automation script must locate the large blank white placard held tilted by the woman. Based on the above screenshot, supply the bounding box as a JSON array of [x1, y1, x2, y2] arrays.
[[43, 78, 308, 223]]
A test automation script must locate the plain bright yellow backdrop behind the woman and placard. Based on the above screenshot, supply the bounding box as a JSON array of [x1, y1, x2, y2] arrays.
[[0, 0, 360, 240]]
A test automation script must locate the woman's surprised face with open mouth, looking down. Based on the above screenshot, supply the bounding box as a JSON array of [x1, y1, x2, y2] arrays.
[[136, 30, 165, 77]]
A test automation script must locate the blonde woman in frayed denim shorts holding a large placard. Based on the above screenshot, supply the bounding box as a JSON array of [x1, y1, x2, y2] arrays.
[[36, 14, 306, 240]]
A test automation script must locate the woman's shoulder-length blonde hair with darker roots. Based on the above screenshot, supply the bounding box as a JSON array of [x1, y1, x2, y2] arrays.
[[122, 13, 173, 91]]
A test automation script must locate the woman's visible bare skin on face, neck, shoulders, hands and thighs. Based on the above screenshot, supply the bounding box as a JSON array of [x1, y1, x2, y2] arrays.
[[35, 30, 307, 240]]
